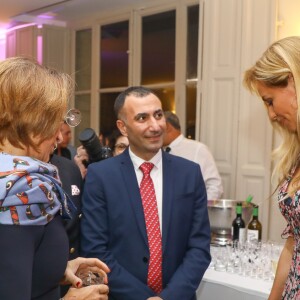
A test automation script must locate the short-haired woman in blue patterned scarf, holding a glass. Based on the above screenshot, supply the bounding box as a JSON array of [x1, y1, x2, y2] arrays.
[[0, 57, 109, 300]]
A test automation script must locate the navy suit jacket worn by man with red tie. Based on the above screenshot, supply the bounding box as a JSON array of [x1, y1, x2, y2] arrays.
[[81, 150, 211, 300]]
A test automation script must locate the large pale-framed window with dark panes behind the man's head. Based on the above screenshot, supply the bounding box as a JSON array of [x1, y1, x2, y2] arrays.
[[76, 0, 199, 138]]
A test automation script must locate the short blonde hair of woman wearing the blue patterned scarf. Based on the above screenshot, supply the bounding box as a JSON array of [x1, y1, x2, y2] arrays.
[[0, 57, 73, 151]]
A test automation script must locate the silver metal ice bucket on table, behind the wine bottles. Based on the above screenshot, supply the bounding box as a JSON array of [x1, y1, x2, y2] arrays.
[[208, 199, 253, 245]]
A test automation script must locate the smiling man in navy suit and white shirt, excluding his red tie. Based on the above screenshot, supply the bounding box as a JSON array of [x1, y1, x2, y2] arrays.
[[81, 87, 211, 300]]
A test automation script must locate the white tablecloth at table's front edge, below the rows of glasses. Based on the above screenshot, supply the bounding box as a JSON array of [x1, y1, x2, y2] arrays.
[[197, 269, 272, 300]]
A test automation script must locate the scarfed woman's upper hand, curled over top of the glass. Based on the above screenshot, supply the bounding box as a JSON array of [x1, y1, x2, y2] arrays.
[[61, 257, 110, 288]]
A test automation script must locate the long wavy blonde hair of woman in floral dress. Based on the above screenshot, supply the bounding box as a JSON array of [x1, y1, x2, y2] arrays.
[[243, 36, 300, 190]]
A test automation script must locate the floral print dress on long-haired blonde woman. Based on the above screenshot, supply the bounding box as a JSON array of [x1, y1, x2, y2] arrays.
[[278, 166, 300, 300]]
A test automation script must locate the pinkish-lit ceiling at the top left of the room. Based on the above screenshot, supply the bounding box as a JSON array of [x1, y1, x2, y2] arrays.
[[0, 0, 153, 29]]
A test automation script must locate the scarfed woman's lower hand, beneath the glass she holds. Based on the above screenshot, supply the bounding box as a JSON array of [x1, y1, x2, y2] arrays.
[[63, 284, 109, 300]]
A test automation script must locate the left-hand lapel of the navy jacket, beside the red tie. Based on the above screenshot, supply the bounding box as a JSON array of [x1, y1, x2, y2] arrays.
[[120, 150, 148, 246]]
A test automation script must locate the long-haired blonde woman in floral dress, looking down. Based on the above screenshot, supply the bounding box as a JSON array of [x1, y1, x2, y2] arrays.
[[244, 37, 300, 300]]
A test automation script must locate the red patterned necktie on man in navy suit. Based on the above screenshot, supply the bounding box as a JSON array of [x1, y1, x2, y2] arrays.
[[140, 162, 162, 294]]
